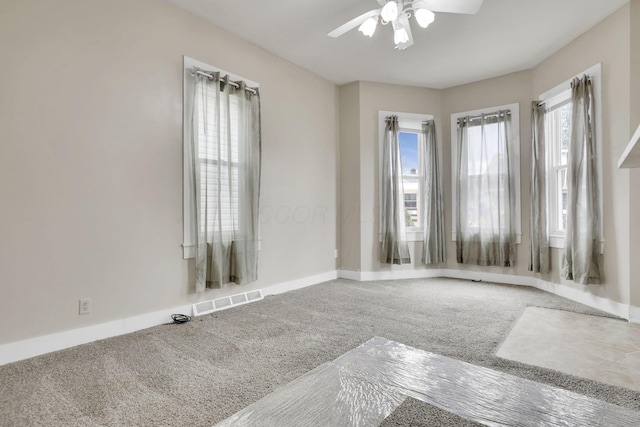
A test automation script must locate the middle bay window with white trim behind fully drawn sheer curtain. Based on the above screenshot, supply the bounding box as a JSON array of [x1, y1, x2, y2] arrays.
[[451, 104, 522, 243]]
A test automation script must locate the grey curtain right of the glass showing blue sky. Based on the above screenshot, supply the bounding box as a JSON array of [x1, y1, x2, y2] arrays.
[[420, 120, 447, 265]]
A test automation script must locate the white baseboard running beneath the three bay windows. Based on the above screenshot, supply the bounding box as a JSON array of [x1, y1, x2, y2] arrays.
[[338, 269, 640, 323]]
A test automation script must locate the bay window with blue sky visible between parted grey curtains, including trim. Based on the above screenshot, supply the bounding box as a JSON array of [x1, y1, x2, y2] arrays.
[[378, 111, 433, 241]]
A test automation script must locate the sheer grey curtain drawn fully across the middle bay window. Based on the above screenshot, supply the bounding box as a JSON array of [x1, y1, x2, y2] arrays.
[[454, 111, 516, 267]]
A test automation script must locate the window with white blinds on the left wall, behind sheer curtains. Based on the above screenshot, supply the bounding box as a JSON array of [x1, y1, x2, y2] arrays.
[[183, 56, 259, 259]]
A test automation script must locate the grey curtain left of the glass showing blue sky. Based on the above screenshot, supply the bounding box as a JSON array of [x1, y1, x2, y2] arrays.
[[380, 116, 411, 264]]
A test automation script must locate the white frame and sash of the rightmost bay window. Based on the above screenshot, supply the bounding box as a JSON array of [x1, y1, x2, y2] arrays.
[[538, 63, 605, 253]]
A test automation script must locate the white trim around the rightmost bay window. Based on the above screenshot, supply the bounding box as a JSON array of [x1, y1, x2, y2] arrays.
[[538, 63, 605, 253]]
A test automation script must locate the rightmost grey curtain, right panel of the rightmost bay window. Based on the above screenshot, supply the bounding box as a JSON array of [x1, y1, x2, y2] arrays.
[[561, 76, 602, 285]]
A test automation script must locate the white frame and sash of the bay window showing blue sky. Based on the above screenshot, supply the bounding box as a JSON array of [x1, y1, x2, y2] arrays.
[[378, 110, 434, 242]]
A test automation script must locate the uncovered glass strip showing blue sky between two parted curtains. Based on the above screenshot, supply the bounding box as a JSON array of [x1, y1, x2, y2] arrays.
[[398, 132, 420, 227]]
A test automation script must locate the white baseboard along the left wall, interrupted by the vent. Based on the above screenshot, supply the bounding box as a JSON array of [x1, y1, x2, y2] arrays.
[[0, 270, 338, 366]]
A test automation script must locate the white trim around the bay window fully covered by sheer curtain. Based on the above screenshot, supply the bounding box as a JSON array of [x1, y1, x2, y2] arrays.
[[451, 103, 522, 244]]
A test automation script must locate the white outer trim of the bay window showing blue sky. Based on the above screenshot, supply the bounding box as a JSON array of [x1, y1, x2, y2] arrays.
[[378, 111, 434, 242]]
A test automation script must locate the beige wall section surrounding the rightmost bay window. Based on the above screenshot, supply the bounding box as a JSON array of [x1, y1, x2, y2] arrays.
[[532, 4, 631, 304]]
